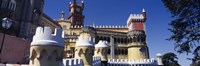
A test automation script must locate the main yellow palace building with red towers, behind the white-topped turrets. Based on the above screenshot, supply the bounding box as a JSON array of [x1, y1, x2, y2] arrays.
[[55, 0, 149, 59]]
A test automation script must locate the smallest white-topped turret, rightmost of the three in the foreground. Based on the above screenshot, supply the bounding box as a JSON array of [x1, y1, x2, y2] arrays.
[[94, 40, 108, 66]]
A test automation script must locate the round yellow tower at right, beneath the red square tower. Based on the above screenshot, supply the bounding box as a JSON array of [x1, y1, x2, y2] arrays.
[[127, 31, 149, 60]]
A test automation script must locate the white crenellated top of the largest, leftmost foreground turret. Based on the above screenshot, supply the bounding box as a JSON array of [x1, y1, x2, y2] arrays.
[[31, 27, 64, 47]]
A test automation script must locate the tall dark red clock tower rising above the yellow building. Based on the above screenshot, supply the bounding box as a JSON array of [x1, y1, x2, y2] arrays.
[[68, 0, 85, 26]]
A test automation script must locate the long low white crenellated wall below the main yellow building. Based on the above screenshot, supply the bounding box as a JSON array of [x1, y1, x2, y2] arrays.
[[108, 59, 157, 66]]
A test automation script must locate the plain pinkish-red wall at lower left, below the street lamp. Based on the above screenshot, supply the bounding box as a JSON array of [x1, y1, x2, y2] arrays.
[[0, 33, 31, 64]]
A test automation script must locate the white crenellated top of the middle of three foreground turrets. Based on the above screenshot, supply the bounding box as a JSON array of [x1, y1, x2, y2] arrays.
[[76, 34, 94, 46]]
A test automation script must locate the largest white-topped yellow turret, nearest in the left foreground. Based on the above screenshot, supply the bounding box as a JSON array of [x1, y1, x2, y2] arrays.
[[29, 27, 64, 66]]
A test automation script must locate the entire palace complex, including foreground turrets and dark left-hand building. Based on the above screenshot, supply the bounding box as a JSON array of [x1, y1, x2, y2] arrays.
[[0, 0, 163, 66]]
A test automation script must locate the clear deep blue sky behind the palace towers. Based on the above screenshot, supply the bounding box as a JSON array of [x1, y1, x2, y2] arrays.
[[44, 0, 191, 66]]
